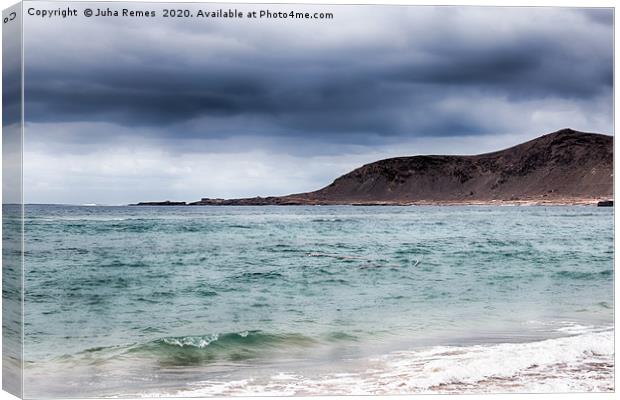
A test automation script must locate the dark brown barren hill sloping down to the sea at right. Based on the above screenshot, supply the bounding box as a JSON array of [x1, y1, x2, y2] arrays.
[[134, 129, 613, 205]]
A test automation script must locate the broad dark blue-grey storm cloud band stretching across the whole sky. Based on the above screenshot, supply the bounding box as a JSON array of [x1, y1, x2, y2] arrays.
[[25, 5, 613, 144]]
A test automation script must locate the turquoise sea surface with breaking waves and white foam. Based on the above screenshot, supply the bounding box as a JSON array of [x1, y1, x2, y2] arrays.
[[24, 205, 614, 398]]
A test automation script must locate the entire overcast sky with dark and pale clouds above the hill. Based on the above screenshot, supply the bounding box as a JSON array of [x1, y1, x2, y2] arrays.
[[24, 3, 613, 204]]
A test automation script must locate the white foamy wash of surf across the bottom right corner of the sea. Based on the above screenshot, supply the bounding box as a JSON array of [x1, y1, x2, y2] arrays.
[[175, 329, 614, 397]]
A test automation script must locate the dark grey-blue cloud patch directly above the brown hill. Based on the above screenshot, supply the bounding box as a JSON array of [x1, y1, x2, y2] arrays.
[[395, 43, 613, 100]]
